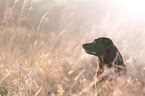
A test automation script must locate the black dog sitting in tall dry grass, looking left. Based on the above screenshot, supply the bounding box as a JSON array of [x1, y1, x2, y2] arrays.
[[82, 37, 126, 74]]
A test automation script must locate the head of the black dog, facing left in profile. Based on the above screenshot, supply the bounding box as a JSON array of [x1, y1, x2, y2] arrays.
[[82, 37, 114, 56]]
